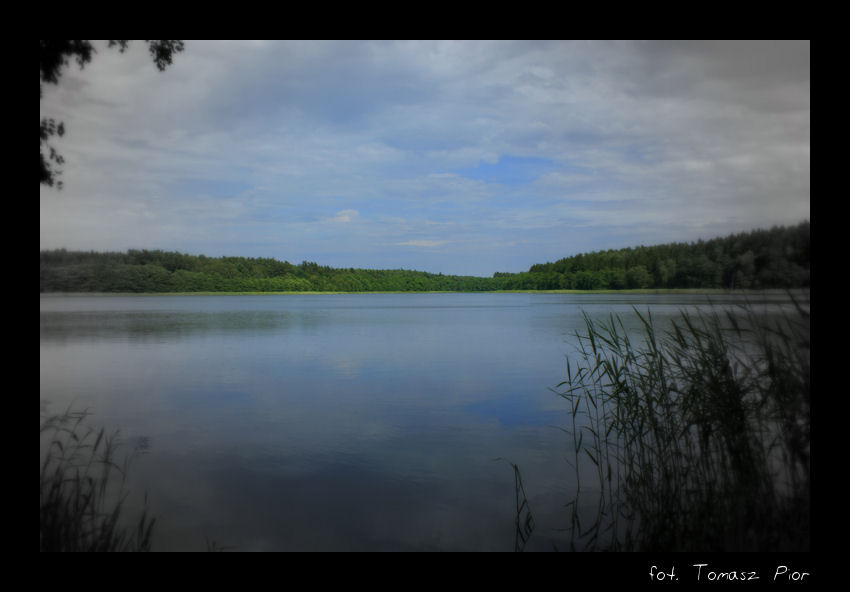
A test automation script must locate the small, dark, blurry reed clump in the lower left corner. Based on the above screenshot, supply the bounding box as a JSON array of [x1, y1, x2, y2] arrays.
[[39, 410, 156, 551]]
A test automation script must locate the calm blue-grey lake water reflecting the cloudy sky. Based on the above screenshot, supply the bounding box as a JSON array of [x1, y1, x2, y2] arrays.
[[40, 293, 800, 551]]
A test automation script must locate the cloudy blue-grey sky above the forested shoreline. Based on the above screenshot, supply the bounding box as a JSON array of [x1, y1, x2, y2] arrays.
[[40, 40, 811, 276]]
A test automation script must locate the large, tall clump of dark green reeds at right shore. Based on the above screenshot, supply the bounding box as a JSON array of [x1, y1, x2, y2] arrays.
[[556, 300, 811, 551]]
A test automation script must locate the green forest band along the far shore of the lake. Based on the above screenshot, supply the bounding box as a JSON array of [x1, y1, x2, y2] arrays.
[[39, 222, 811, 292]]
